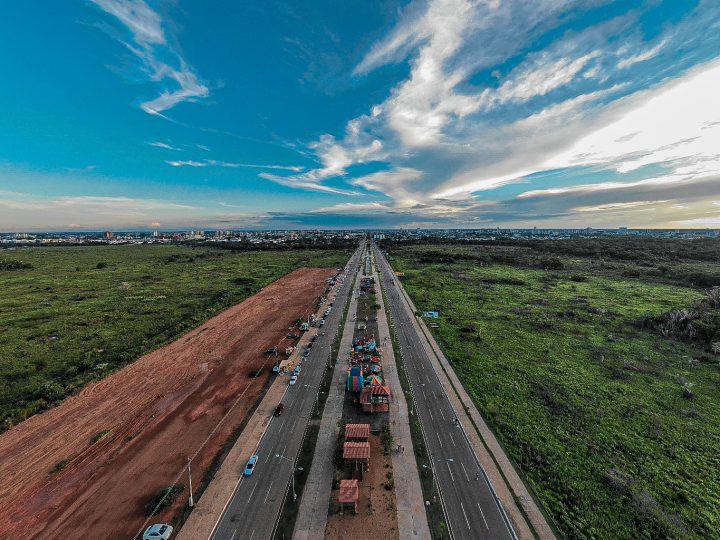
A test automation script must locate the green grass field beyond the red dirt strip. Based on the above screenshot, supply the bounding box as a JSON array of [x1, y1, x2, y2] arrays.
[[0, 245, 348, 429]]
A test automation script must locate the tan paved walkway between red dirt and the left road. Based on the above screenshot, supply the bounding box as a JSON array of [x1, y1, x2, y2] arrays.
[[177, 264, 352, 540]]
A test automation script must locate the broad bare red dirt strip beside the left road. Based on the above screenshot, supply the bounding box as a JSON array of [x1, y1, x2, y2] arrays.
[[0, 269, 332, 540]]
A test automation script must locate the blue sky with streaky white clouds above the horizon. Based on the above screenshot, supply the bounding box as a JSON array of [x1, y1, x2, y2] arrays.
[[0, 0, 720, 231]]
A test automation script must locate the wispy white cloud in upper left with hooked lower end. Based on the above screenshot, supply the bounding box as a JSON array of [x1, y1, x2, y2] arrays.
[[90, 0, 210, 116]]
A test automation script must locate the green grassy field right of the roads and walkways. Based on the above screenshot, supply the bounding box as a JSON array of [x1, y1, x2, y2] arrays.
[[390, 247, 720, 539]]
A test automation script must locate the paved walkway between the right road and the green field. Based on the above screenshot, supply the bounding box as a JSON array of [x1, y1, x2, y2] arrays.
[[397, 266, 555, 540]]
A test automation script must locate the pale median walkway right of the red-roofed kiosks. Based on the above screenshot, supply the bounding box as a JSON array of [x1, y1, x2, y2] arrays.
[[373, 254, 431, 540]]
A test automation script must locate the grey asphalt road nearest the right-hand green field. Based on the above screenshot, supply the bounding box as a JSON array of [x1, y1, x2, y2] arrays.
[[373, 246, 513, 540]]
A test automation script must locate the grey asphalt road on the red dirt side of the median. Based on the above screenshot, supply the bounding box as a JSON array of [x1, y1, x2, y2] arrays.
[[212, 244, 364, 540]]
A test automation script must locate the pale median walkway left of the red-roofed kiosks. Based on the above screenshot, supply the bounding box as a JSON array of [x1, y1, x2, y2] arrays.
[[293, 256, 360, 540]]
